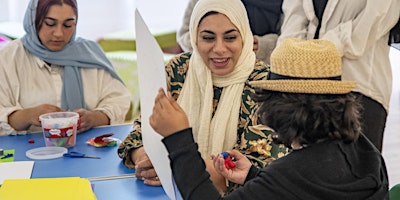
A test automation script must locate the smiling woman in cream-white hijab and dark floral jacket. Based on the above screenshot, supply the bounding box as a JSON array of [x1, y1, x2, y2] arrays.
[[118, 0, 287, 194]]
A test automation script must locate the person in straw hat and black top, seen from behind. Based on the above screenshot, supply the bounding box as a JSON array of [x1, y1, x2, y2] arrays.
[[150, 39, 388, 200]]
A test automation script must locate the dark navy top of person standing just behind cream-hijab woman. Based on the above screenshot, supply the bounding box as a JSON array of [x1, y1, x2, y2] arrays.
[[242, 0, 282, 36]]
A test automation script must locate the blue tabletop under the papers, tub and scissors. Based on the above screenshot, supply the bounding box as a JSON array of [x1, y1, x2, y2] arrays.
[[0, 124, 169, 200]]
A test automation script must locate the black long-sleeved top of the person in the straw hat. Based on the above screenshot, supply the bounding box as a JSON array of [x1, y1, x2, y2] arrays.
[[163, 129, 388, 200]]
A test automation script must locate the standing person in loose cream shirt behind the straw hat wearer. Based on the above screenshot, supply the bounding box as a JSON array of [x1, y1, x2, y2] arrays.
[[277, 0, 400, 151]]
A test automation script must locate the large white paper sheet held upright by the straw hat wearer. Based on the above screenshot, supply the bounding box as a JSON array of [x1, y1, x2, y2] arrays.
[[135, 9, 181, 200]]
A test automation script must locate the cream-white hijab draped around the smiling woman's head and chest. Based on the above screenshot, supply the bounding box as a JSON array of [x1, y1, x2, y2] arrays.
[[178, 0, 255, 158]]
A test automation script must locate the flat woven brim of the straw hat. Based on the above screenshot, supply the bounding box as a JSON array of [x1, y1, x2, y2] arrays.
[[250, 80, 356, 94]]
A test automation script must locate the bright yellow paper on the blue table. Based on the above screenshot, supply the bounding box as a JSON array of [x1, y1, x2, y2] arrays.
[[0, 177, 96, 200]]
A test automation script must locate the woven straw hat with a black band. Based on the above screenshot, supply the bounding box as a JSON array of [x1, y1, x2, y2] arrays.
[[250, 38, 356, 94]]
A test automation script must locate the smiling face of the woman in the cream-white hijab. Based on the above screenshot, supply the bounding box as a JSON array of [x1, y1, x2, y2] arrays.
[[197, 13, 243, 76]]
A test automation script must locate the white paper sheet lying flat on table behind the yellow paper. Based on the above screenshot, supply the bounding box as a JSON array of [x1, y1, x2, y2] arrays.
[[0, 161, 34, 185]]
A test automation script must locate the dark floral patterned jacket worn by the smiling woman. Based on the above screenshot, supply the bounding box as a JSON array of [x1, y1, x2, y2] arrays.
[[118, 52, 288, 192]]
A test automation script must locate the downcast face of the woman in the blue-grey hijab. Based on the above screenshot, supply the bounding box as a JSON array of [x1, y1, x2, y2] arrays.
[[38, 4, 76, 51]]
